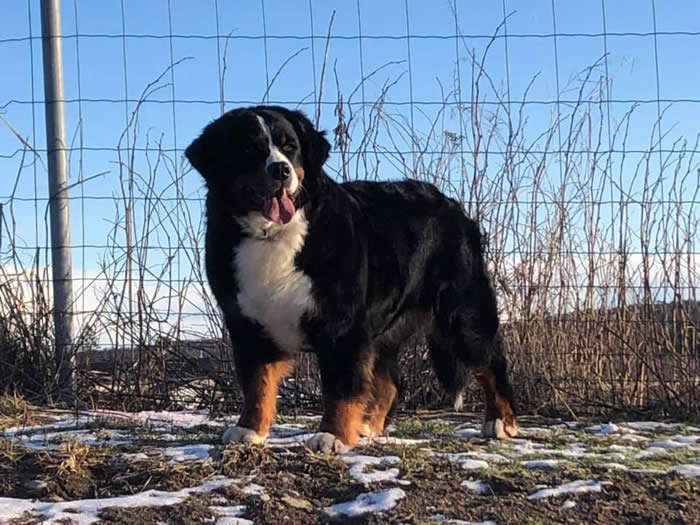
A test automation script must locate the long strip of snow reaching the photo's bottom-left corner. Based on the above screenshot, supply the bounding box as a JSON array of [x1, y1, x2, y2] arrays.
[[0, 476, 234, 525]]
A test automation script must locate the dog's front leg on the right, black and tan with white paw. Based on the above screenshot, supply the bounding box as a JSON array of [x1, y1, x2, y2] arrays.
[[309, 345, 374, 452]]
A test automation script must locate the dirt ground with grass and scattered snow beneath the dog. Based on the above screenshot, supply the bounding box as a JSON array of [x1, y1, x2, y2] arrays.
[[0, 412, 700, 525]]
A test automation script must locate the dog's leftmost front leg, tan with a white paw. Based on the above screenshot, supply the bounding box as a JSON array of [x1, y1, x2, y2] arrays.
[[222, 353, 294, 444]]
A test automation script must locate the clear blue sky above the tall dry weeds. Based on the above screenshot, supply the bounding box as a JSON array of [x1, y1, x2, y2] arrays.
[[0, 0, 700, 334]]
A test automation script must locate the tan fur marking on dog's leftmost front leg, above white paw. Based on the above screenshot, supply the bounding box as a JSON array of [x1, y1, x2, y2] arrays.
[[238, 358, 294, 437]]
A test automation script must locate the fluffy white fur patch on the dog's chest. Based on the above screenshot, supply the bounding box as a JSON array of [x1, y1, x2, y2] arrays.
[[234, 210, 313, 352]]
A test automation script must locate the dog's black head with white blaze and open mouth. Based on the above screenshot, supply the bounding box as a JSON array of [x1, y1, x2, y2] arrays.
[[185, 106, 330, 224]]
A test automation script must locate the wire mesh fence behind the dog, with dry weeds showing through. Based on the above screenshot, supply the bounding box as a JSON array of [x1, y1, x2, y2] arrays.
[[0, 0, 700, 414]]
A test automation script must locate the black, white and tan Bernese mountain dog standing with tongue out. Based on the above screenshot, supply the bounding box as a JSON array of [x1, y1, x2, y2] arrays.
[[185, 106, 517, 452]]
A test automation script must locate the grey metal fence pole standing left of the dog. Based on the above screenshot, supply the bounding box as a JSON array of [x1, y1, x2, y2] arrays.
[[41, 0, 73, 401]]
